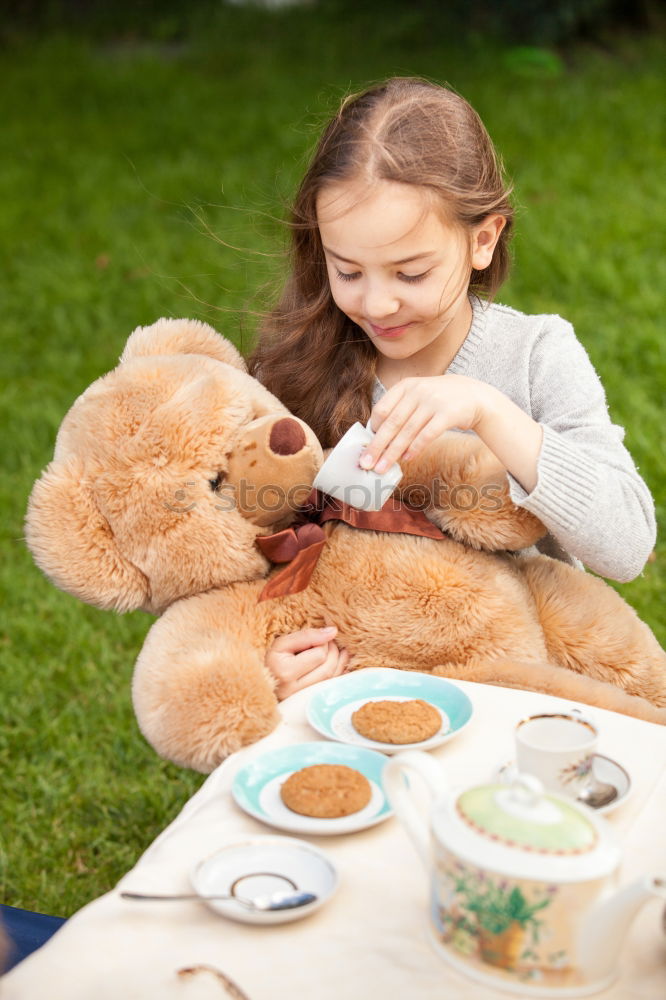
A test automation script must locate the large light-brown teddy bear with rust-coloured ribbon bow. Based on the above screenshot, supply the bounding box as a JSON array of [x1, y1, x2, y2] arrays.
[[26, 319, 666, 772]]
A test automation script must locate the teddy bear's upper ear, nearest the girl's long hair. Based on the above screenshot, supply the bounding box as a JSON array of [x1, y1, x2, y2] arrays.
[[120, 319, 247, 371]]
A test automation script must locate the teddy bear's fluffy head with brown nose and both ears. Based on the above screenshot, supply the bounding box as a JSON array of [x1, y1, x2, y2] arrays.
[[26, 319, 322, 613]]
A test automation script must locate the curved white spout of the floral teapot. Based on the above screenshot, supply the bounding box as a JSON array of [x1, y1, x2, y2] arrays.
[[579, 875, 666, 982]]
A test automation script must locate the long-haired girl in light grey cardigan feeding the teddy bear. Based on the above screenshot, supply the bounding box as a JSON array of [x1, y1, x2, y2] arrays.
[[250, 79, 656, 698]]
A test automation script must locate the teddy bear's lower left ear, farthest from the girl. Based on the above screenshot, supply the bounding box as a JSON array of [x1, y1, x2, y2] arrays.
[[25, 460, 150, 611]]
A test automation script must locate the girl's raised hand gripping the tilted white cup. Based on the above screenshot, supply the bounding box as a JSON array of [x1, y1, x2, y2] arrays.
[[360, 375, 486, 474]]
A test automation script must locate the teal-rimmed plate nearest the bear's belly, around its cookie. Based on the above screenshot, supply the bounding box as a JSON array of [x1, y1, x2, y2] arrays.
[[307, 667, 473, 753]]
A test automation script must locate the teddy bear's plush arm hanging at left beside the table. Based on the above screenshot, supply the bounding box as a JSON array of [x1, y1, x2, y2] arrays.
[[132, 588, 280, 773]]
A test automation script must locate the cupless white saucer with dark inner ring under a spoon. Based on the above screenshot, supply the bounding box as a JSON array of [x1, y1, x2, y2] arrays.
[[190, 837, 338, 924]]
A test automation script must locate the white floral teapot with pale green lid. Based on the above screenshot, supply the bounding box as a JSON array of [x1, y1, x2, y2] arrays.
[[382, 750, 666, 997]]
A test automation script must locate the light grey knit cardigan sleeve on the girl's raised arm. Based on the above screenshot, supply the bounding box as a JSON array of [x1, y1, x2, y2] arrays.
[[509, 316, 656, 582]]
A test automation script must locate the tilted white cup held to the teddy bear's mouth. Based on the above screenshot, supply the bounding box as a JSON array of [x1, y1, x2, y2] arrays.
[[313, 423, 402, 510]]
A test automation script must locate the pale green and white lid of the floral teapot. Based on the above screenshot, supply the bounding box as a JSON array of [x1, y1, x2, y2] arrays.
[[456, 774, 598, 857]]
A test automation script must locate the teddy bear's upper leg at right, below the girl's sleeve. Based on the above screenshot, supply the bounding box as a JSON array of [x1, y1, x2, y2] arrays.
[[522, 556, 666, 706]]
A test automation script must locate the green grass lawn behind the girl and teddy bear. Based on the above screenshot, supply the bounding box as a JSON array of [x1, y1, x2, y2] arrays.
[[0, 5, 666, 915]]
